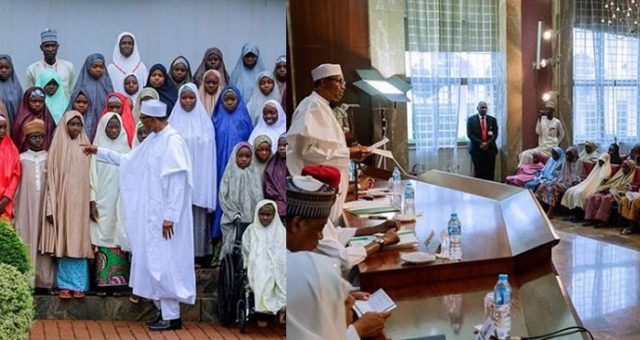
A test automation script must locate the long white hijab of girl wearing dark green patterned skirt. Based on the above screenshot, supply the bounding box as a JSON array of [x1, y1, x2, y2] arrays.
[[90, 112, 131, 251]]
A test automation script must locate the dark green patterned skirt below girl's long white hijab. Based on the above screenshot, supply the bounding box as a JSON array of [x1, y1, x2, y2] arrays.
[[96, 247, 129, 287]]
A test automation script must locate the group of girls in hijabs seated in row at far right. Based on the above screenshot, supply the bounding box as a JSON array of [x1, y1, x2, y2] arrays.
[[507, 142, 640, 228]]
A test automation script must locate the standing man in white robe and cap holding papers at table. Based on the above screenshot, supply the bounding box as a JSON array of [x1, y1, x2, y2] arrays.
[[287, 64, 397, 271]]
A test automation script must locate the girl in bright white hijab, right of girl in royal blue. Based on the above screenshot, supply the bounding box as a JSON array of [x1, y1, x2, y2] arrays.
[[249, 100, 287, 153]]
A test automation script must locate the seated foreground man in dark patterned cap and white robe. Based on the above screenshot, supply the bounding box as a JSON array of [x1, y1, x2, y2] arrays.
[[287, 176, 391, 340]]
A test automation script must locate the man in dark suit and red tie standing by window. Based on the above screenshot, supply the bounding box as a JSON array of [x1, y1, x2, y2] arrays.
[[467, 102, 498, 181]]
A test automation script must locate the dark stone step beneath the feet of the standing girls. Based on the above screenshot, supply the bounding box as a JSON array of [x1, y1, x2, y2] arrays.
[[34, 268, 218, 321]]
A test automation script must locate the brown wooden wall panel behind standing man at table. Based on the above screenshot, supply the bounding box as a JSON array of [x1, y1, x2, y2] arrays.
[[288, 0, 373, 145]]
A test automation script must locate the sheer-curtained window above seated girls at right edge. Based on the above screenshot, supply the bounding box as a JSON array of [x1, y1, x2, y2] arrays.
[[572, 0, 640, 152]]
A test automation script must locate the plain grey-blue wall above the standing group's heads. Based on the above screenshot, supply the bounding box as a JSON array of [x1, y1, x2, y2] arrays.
[[0, 0, 286, 86]]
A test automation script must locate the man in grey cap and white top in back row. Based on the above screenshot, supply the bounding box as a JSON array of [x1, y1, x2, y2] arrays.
[[25, 28, 76, 98]]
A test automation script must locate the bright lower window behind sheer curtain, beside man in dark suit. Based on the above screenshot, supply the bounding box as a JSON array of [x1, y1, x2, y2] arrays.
[[405, 52, 502, 143]]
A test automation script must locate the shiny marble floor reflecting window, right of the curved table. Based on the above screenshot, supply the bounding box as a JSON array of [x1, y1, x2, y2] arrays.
[[552, 219, 640, 340]]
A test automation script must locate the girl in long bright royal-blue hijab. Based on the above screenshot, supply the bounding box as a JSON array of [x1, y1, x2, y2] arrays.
[[211, 86, 253, 254]]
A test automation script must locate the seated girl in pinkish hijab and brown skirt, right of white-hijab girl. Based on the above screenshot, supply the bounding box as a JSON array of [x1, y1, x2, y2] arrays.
[[582, 160, 636, 227]]
